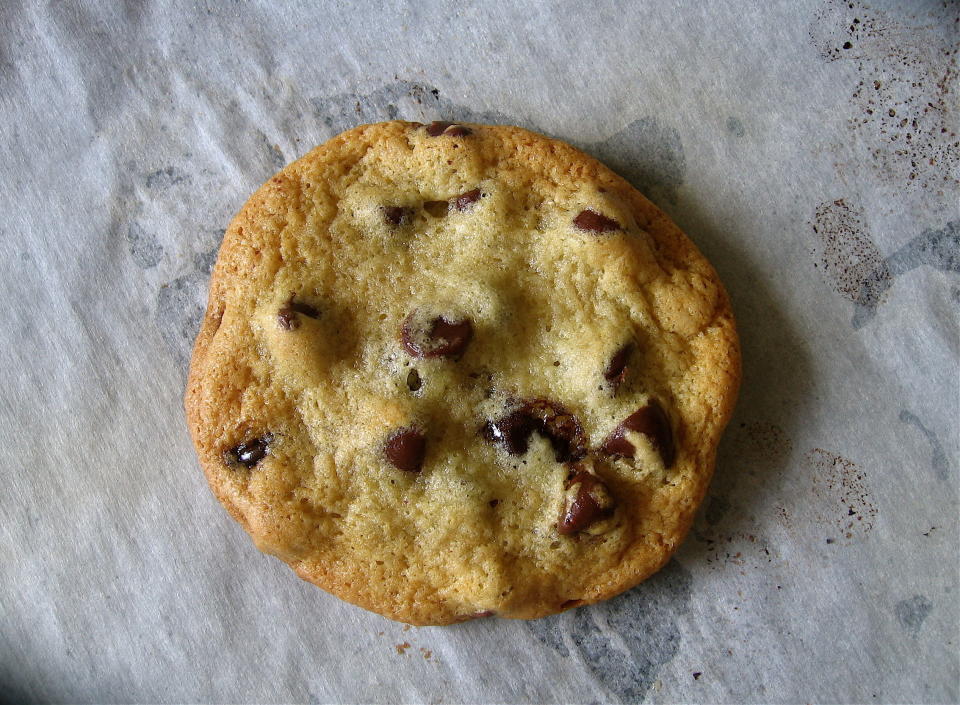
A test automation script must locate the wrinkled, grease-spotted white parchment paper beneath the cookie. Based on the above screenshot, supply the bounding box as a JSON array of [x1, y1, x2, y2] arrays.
[[0, 0, 960, 703]]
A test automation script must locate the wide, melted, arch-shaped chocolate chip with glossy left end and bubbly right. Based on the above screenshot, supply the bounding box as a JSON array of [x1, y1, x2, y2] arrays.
[[482, 399, 587, 463]]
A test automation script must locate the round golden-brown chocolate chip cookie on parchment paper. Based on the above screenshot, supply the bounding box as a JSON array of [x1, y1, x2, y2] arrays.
[[186, 122, 740, 624]]
